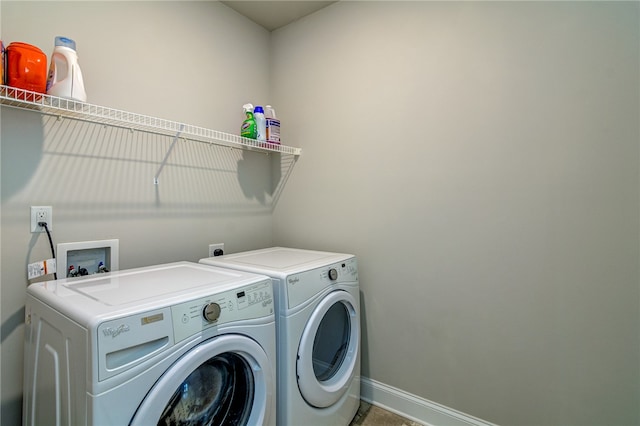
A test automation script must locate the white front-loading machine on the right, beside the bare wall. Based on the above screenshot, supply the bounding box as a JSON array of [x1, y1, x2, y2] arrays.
[[200, 247, 360, 426]]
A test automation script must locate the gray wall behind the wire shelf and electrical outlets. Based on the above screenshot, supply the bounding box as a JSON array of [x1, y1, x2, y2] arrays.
[[0, 1, 280, 425]]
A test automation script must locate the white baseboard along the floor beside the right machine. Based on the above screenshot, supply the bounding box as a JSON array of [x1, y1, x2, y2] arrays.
[[360, 377, 496, 426]]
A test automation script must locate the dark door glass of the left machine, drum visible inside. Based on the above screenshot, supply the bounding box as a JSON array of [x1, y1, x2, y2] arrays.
[[158, 352, 254, 426]]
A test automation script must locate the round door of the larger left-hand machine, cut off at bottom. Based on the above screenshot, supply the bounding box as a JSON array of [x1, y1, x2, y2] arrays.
[[131, 335, 274, 426]]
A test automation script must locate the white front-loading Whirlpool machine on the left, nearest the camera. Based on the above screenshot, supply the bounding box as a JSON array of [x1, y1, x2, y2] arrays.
[[23, 262, 276, 426]]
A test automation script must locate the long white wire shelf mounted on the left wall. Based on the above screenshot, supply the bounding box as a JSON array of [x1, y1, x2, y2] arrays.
[[0, 85, 302, 156]]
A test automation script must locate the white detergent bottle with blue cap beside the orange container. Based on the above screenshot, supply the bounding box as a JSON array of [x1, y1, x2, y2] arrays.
[[47, 37, 87, 102]]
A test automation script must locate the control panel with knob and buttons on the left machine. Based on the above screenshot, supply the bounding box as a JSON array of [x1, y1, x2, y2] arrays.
[[171, 280, 274, 343]]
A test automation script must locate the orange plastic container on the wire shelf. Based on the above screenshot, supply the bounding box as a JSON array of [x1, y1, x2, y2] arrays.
[[6, 42, 47, 93]]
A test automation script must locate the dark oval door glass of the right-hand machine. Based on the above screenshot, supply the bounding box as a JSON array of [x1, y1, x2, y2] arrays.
[[313, 302, 351, 382]]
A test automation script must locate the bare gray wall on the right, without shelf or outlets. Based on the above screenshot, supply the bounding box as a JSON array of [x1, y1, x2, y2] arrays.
[[271, 2, 640, 425]]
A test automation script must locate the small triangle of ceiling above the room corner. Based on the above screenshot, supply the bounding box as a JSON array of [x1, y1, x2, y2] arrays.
[[221, 0, 336, 31]]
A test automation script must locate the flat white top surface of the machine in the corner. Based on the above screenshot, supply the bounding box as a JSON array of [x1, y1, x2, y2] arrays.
[[200, 247, 353, 274]]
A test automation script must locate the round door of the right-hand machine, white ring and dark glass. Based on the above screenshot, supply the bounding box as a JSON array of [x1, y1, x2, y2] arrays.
[[296, 290, 360, 408]]
